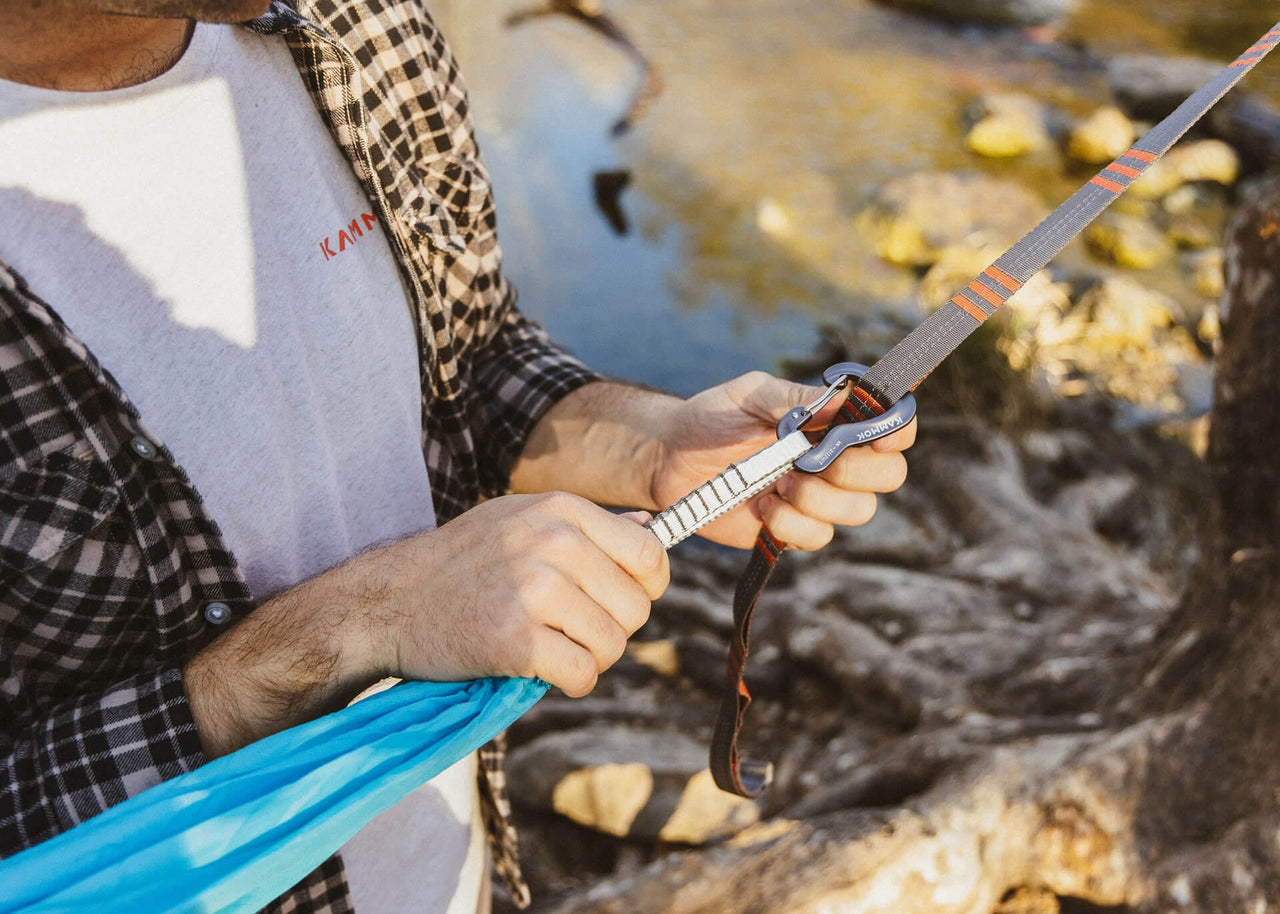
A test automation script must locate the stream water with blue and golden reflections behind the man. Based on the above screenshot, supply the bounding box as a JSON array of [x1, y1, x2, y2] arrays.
[[433, 0, 1280, 407]]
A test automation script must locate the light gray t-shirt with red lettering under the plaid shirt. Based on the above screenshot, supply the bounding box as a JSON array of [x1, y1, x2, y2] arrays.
[[0, 24, 485, 914]]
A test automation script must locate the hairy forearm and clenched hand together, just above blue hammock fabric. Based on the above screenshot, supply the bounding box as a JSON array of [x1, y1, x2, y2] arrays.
[[184, 493, 669, 758]]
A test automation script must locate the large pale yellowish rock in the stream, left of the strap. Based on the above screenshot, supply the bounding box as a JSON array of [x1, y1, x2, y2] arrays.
[[858, 172, 1047, 266]]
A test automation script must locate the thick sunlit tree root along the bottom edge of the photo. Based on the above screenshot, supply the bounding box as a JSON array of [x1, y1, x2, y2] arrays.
[[536, 722, 1158, 914]]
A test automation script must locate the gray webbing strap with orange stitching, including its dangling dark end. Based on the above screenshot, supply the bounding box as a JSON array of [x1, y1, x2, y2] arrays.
[[710, 23, 1280, 798]]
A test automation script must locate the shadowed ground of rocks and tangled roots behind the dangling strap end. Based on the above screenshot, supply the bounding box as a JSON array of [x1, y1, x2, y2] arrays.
[[499, 397, 1203, 910]]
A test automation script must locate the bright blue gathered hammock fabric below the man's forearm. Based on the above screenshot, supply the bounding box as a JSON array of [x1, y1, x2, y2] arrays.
[[0, 678, 548, 914]]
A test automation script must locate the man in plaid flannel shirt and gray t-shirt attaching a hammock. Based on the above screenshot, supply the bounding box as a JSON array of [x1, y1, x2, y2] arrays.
[[0, 0, 914, 914]]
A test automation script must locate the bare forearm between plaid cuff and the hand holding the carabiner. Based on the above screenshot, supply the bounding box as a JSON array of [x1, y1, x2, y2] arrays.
[[511, 381, 684, 511]]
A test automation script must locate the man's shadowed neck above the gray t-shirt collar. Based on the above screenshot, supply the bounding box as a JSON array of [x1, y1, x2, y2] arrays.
[[0, 6, 192, 92]]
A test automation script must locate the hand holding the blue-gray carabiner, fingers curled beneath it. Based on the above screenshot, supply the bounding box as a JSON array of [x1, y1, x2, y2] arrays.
[[652, 371, 916, 549]]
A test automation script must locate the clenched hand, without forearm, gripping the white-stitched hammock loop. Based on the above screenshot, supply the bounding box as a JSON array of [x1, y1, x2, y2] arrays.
[[380, 493, 668, 698]]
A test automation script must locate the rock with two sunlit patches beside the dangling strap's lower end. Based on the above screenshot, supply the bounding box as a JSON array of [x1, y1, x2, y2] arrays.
[[508, 727, 760, 844]]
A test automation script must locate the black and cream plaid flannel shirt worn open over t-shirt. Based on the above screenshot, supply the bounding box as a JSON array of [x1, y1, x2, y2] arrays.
[[0, 0, 596, 911]]
